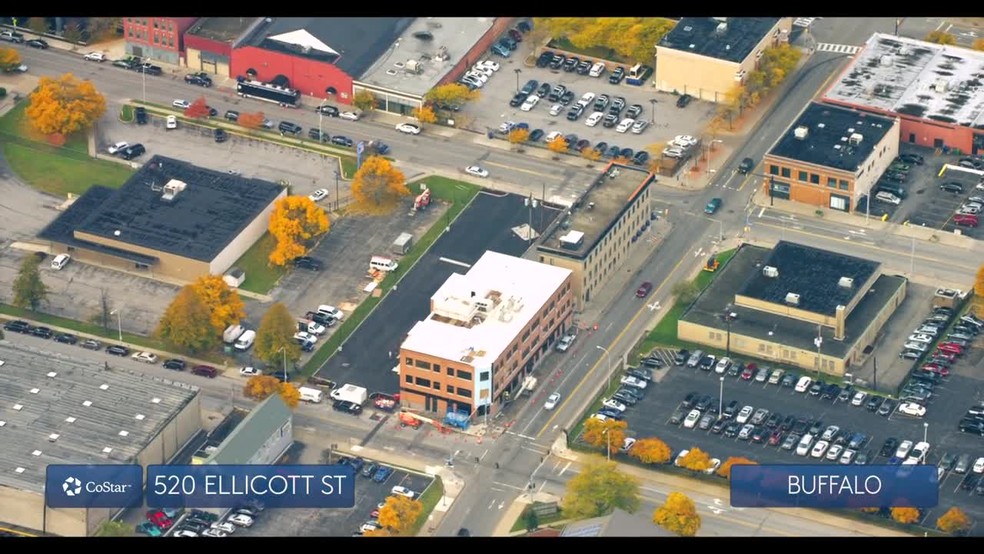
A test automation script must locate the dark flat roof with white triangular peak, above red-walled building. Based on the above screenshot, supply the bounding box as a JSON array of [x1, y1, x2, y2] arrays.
[[244, 17, 416, 78]]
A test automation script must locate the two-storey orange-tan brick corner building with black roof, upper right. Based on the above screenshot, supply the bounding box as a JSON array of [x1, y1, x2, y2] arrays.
[[763, 103, 900, 212]]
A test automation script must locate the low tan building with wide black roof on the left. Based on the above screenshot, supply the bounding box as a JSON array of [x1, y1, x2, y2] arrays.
[[38, 156, 287, 282]]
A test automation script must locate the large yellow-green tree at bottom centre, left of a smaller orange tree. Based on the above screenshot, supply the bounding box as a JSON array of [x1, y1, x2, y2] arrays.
[[563, 454, 639, 519]]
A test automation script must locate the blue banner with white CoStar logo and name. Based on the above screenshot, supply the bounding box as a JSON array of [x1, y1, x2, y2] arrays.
[[44, 464, 143, 508]]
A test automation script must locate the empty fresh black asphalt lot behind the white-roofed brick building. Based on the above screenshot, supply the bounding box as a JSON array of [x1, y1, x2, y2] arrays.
[[317, 193, 560, 393]]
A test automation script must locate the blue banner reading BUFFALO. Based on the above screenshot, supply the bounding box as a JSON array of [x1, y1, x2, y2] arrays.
[[731, 464, 940, 508]]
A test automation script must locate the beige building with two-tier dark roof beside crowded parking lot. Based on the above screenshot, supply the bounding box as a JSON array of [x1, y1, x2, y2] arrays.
[[677, 241, 908, 376]]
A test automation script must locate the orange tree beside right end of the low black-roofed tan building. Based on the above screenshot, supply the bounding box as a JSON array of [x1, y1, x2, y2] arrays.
[[269, 196, 329, 266]]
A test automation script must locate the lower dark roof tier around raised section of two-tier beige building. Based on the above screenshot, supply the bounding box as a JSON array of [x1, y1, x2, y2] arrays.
[[680, 244, 906, 359]]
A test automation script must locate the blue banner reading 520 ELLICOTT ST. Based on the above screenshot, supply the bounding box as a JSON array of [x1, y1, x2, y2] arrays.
[[147, 464, 355, 508]]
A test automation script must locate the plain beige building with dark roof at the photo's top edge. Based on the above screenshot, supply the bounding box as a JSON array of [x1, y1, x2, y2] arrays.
[[654, 17, 793, 102]]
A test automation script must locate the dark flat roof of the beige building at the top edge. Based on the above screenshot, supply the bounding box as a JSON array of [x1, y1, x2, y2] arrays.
[[656, 17, 780, 63]]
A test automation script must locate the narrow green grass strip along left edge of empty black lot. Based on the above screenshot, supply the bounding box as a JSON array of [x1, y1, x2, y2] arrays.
[[302, 177, 481, 375]]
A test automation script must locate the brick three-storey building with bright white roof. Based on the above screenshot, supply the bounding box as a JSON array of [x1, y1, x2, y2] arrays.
[[399, 251, 574, 416]]
